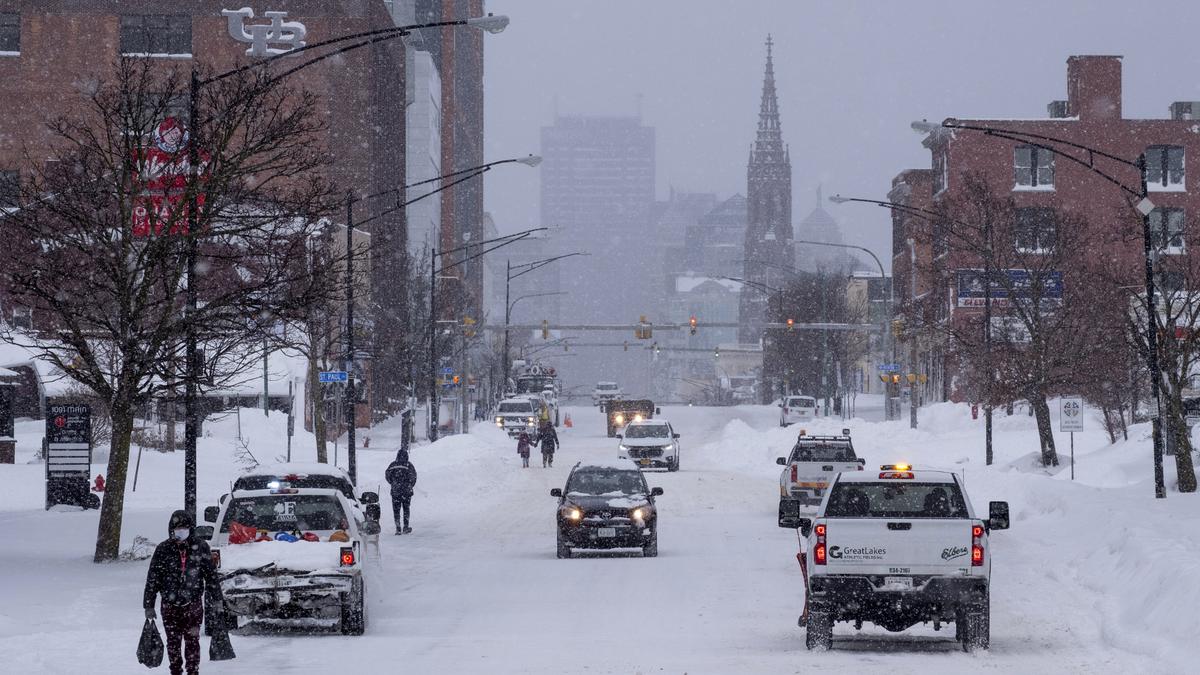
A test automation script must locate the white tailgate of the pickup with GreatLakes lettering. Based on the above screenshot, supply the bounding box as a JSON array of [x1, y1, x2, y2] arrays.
[[826, 518, 971, 574]]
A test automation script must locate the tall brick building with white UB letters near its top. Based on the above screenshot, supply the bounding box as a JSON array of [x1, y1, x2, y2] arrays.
[[0, 0, 406, 419]]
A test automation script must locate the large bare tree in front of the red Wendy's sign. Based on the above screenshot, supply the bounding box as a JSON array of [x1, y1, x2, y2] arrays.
[[0, 59, 343, 562]]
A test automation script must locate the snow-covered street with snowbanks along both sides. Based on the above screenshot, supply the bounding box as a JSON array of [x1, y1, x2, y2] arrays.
[[0, 405, 1200, 673]]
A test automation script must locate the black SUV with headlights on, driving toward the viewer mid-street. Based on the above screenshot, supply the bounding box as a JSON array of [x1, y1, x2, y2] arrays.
[[550, 460, 662, 557]]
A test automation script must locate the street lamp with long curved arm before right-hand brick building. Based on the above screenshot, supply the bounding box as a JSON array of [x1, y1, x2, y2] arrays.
[[912, 119, 1166, 498]]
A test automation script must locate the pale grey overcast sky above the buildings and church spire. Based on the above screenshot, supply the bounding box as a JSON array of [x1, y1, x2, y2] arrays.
[[485, 0, 1200, 270]]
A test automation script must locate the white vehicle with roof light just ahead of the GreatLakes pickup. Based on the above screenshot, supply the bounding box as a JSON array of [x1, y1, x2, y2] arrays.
[[775, 429, 865, 520]]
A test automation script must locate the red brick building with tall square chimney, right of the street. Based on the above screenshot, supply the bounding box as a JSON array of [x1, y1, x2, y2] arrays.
[[889, 55, 1200, 400]]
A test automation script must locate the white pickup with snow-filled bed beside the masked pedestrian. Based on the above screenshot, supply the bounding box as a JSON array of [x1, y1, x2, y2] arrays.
[[204, 486, 379, 635]]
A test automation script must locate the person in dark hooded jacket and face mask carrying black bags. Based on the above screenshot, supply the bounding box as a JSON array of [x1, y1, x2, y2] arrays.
[[142, 510, 224, 675]]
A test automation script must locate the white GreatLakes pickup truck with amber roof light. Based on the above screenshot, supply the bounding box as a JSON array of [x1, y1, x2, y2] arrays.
[[779, 465, 1008, 651]]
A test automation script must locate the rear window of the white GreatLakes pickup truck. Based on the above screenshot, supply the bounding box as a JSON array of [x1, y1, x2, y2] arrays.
[[824, 480, 967, 518]]
